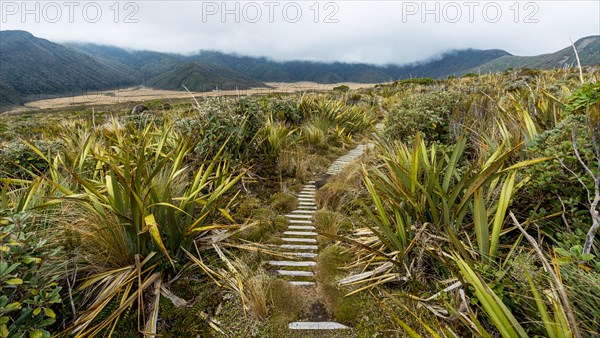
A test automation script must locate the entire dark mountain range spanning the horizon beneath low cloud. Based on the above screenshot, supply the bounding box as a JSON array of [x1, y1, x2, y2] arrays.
[[0, 31, 600, 107]]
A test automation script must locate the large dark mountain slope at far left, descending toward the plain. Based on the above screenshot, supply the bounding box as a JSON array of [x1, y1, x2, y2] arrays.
[[0, 31, 135, 104]]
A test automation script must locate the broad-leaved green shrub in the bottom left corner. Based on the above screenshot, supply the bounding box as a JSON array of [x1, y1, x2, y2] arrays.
[[0, 211, 61, 338]]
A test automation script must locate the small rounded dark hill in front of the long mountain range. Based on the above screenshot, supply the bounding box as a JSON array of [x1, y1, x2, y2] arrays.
[[146, 62, 265, 92]]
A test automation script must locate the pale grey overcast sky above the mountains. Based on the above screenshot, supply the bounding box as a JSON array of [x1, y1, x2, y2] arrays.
[[0, 0, 600, 64]]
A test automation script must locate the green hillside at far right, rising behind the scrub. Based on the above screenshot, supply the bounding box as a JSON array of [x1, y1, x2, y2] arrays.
[[471, 35, 600, 73]]
